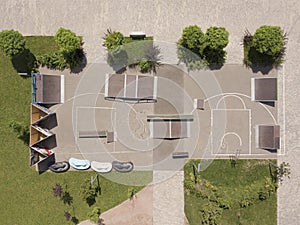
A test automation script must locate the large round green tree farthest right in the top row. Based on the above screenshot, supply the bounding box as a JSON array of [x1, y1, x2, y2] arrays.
[[253, 25, 284, 57]]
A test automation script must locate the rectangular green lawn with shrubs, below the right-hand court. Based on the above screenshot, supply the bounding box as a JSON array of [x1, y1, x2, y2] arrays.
[[184, 160, 277, 225]]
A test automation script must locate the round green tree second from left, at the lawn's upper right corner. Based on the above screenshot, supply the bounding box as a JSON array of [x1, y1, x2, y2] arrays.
[[54, 27, 81, 53]]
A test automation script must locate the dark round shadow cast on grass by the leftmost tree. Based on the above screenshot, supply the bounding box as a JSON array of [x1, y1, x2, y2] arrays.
[[11, 49, 37, 74]]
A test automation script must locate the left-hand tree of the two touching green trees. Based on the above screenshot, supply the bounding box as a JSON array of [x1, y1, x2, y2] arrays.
[[177, 25, 204, 56]]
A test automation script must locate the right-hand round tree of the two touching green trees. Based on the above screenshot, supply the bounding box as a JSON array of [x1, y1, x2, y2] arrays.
[[205, 27, 229, 50]]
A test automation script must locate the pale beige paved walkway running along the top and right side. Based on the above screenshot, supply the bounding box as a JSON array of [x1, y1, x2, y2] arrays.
[[0, 0, 300, 225]]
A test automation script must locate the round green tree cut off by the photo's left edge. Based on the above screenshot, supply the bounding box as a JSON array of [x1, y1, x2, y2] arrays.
[[0, 30, 25, 57]]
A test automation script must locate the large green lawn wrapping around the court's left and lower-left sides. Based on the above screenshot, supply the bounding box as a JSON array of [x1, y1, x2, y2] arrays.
[[0, 37, 152, 225]]
